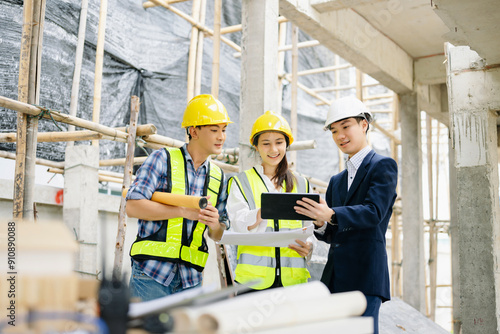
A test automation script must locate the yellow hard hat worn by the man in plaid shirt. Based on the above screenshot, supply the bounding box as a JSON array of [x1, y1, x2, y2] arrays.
[[181, 94, 233, 128]]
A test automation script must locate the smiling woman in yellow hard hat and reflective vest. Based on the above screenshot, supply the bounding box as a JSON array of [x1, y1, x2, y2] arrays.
[[227, 111, 312, 290]]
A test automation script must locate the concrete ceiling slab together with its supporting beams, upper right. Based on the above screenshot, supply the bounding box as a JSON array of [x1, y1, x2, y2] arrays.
[[279, 0, 500, 124]]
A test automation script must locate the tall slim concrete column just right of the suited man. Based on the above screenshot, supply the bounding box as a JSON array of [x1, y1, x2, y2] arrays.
[[399, 93, 425, 314]]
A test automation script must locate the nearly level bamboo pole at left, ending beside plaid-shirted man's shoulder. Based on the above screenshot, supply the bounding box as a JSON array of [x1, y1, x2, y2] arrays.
[[0, 124, 156, 143]]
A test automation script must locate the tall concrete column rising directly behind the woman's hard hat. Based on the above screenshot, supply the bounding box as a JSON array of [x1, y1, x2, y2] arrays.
[[239, 0, 280, 170]]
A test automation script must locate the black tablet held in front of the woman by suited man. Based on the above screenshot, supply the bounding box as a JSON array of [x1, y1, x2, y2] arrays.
[[260, 193, 319, 220]]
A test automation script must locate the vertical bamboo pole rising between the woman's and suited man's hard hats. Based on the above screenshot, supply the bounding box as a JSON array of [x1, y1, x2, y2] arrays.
[[290, 24, 299, 171]]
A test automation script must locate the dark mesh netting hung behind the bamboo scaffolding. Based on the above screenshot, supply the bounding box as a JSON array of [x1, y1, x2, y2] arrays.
[[0, 0, 390, 181]]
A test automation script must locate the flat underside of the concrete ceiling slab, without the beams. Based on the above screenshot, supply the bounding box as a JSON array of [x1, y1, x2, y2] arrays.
[[310, 0, 500, 64]]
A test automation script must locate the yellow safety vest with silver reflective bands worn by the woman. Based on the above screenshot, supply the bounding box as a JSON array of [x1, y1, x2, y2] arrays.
[[229, 168, 311, 290]]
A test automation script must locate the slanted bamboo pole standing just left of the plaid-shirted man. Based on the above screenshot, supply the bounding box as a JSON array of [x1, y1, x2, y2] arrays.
[[113, 96, 140, 281]]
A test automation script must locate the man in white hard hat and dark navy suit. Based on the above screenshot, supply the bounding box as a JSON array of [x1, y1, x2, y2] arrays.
[[295, 97, 398, 333]]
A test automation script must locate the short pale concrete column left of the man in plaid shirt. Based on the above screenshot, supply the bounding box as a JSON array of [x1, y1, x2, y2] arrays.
[[63, 145, 100, 276]]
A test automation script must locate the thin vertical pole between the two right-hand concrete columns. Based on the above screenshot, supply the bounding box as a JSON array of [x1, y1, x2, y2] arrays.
[[425, 114, 437, 321]]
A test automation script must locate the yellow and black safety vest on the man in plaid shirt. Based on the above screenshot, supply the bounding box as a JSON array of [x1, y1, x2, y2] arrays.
[[130, 148, 224, 272]]
